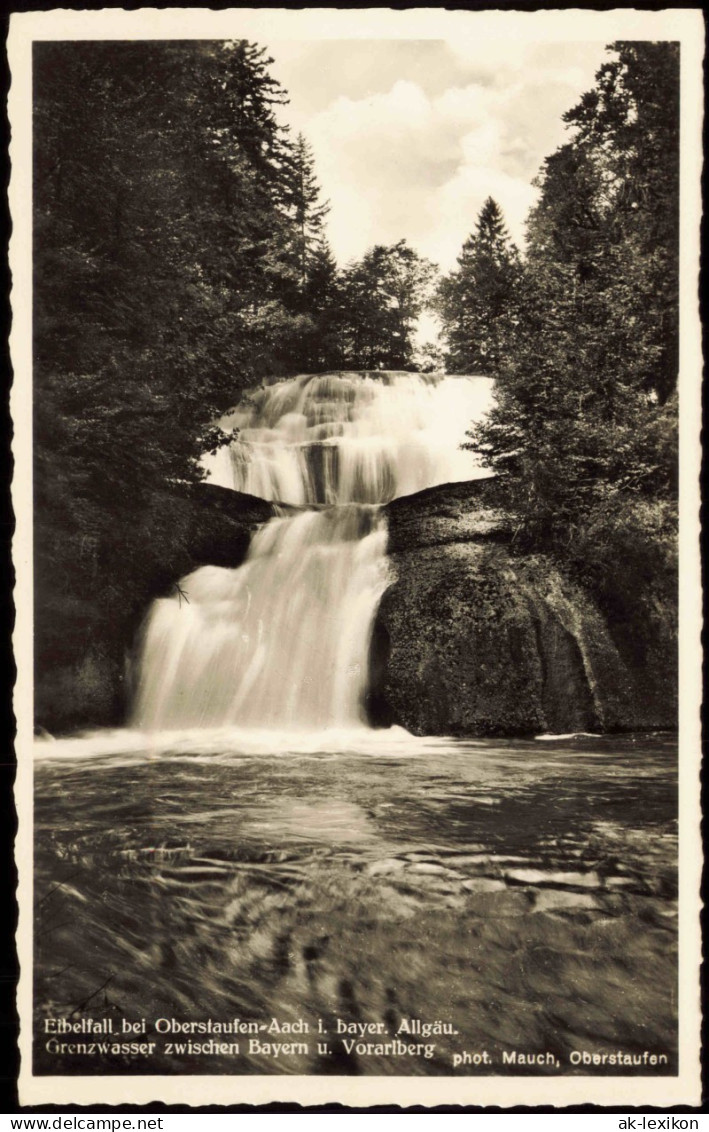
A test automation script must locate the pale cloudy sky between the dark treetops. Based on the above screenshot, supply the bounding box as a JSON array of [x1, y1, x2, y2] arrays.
[[262, 37, 607, 269]]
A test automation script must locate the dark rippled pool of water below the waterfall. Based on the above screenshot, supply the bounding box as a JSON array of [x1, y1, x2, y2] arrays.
[[35, 731, 676, 1074]]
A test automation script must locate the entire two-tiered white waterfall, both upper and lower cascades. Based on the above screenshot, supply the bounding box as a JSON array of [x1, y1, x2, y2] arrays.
[[134, 372, 492, 730]]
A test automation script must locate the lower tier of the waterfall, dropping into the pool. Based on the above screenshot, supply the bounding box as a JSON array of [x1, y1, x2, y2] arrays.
[[133, 504, 388, 729]]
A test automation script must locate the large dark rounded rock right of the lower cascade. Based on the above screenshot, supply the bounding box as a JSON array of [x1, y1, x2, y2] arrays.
[[369, 480, 676, 736]]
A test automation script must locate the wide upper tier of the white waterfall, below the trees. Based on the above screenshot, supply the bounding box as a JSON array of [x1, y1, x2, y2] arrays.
[[204, 370, 493, 506]]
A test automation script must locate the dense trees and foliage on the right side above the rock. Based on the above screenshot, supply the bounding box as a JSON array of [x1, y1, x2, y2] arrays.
[[438, 42, 680, 647]]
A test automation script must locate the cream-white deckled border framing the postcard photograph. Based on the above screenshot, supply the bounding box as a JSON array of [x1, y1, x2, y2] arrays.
[[8, 8, 704, 1108]]
